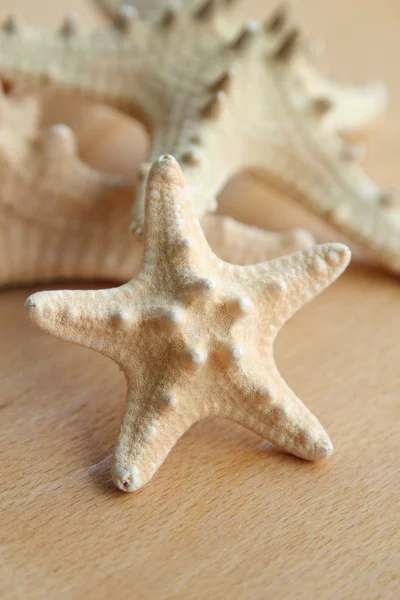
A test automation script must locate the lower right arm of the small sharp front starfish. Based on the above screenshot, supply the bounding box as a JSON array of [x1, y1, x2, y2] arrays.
[[226, 366, 333, 460]]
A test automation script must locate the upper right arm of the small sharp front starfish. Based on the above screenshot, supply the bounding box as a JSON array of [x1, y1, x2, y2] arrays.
[[235, 244, 351, 328]]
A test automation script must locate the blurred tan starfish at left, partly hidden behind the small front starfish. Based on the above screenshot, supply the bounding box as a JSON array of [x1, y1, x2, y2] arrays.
[[0, 86, 313, 285]]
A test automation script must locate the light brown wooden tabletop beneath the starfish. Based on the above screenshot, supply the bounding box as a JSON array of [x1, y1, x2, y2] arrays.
[[0, 0, 400, 600]]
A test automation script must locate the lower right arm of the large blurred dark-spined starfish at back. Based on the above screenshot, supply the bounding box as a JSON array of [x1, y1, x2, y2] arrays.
[[255, 122, 400, 272]]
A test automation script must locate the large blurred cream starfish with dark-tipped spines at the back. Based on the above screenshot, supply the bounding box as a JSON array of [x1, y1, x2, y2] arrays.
[[0, 0, 394, 271]]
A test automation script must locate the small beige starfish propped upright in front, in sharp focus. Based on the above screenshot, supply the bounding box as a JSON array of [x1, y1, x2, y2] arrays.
[[26, 156, 350, 491]]
